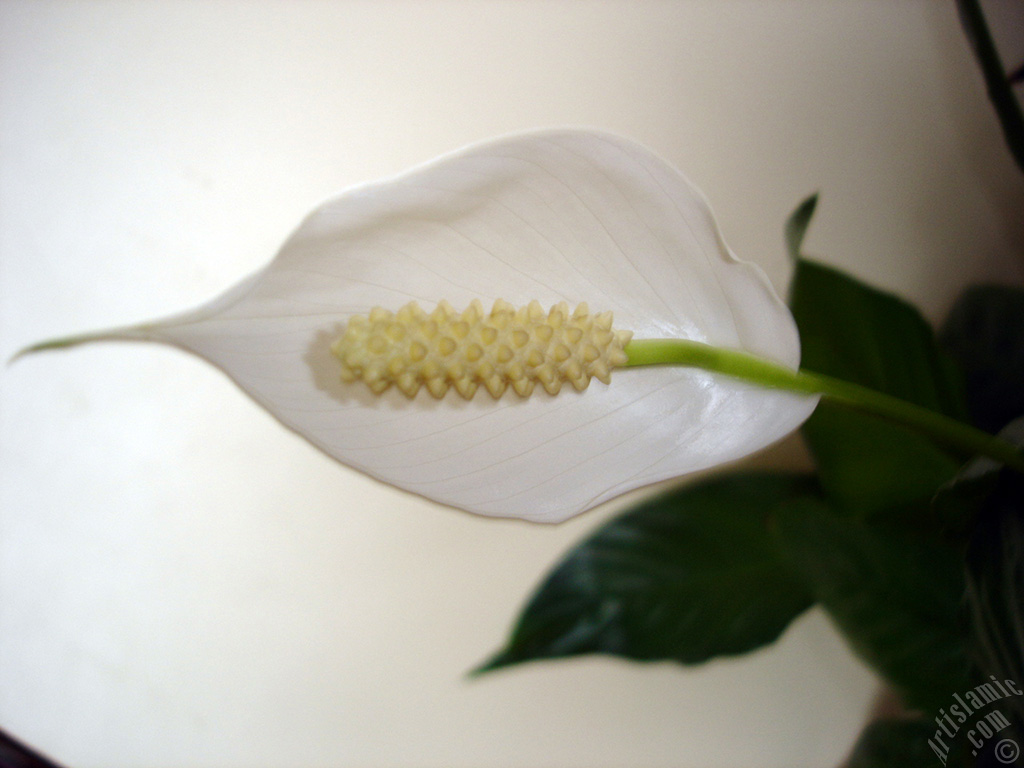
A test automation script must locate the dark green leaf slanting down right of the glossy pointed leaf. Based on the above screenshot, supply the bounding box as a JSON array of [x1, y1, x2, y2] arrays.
[[775, 499, 968, 711]]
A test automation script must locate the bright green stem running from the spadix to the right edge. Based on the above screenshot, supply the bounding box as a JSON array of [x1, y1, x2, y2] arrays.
[[626, 339, 1024, 472]]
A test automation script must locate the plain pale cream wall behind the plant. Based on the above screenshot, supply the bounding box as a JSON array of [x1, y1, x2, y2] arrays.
[[0, 0, 1024, 768]]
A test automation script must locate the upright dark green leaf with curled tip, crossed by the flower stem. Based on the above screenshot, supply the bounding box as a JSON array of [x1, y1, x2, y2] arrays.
[[786, 199, 967, 514]]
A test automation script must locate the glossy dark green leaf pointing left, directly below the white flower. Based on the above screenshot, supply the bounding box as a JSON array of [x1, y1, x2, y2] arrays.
[[479, 474, 814, 672]]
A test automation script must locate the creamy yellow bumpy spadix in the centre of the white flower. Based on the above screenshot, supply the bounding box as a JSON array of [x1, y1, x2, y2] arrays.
[[331, 299, 633, 399]]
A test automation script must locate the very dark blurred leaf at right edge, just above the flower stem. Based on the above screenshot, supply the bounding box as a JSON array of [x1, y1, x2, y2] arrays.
[[940, 286, 1024, 432]]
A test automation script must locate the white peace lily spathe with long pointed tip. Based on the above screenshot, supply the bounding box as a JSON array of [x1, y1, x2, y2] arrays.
[[19, 130, 817, 521]]
